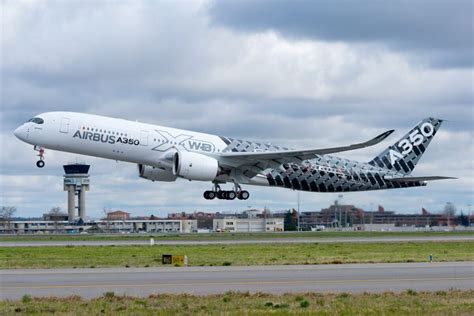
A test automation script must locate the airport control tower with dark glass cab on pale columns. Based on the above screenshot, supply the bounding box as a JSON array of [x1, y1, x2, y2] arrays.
[[63, 164, 90, 223]]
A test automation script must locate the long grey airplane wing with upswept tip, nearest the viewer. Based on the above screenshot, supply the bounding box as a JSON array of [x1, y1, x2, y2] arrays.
[[216, 130, 393, 173]]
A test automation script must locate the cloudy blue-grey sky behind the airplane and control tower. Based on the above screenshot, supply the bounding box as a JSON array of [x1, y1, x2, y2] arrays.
[[0, 0, 474, 217]]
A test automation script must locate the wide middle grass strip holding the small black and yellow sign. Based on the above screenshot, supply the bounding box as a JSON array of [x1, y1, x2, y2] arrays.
[[0, 241, 474, 269]]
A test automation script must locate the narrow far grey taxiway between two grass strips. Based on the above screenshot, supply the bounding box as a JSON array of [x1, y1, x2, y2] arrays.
[[0, 234, 474, 247]]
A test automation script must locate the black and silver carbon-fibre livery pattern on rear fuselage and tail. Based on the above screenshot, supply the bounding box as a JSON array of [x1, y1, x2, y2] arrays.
[[221, 118, 442, 192]]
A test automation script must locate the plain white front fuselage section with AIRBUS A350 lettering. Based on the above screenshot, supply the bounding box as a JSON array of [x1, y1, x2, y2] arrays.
[[14, 112, 230, 167]]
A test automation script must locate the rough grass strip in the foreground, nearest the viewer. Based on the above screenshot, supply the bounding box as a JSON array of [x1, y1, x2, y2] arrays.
[[0, 290, 474, 315]]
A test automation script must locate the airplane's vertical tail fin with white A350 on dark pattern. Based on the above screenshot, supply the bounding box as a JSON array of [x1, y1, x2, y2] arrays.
[[369, 118, 443, 175]]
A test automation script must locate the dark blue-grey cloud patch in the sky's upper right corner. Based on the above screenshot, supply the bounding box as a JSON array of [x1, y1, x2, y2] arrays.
[[210, 0, 473, 68]]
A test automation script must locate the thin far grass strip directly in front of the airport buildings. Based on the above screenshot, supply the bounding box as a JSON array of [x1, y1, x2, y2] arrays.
[[0, 231, 474, 245]]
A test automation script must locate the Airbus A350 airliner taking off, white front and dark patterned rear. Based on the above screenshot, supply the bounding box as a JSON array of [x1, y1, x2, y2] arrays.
[[14, 112, 455, 200]]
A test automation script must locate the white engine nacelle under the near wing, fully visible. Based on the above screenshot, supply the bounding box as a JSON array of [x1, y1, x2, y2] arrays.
[[173, 151, 219, 181]]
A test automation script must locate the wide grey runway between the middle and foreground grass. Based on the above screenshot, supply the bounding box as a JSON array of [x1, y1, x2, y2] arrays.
[[0, 262, 474, 299]]
